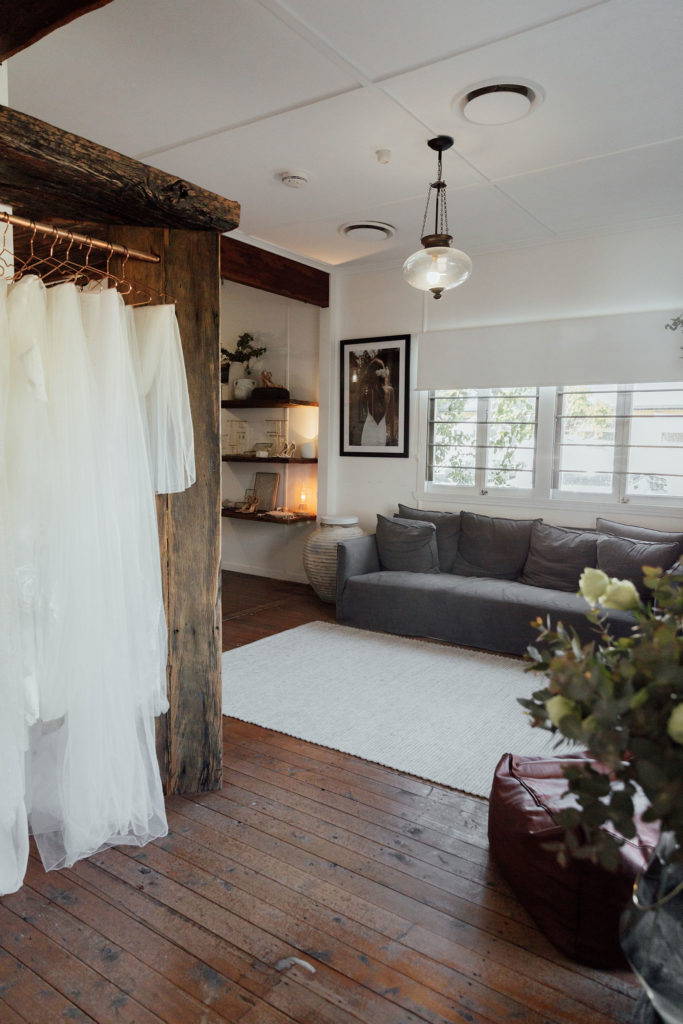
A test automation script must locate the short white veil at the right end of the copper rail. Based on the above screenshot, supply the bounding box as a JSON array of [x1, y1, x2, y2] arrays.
[[134, 304, 197, 495]]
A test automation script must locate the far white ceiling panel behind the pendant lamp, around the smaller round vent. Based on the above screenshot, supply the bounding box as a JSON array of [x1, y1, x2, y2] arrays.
[[250, 185, 552, 264]]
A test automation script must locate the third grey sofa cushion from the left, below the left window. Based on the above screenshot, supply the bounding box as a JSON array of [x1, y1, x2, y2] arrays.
[[452, 512, 543, 580]]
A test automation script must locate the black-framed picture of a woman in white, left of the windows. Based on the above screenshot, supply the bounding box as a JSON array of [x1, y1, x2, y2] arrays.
[[339, 334, 411, 459]]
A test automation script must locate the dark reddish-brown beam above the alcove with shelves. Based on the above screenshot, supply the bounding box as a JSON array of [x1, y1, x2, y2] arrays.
[[220, 237, 330, 308]]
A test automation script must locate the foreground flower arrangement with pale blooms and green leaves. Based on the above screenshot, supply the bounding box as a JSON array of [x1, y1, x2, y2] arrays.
[[519, 566, 683, 868]]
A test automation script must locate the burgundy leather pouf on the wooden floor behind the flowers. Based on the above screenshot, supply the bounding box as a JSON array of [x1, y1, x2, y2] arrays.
[[488, 754, 657, 968]]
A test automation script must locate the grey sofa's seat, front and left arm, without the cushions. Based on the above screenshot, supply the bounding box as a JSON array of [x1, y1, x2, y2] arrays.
[[337, 512, 683, 654]]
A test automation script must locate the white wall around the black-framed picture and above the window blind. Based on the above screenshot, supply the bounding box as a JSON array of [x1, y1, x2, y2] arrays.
[[321, 225, 683, 529]]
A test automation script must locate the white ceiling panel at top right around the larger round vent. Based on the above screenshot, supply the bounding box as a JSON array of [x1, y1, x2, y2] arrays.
[[383, 0, 683, 179]]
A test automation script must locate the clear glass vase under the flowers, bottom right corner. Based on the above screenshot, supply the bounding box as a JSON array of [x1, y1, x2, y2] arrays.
[[622, 833, 683, 1024]]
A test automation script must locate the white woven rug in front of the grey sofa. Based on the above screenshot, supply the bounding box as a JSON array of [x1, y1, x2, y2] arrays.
[[223, 623, 554, 797]]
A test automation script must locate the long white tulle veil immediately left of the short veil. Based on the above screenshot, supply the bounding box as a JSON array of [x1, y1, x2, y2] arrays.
[[81, 286, 168, 715]]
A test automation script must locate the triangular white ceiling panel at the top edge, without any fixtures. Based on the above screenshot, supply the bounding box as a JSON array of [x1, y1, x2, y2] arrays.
[[280, 0, 604, 78]]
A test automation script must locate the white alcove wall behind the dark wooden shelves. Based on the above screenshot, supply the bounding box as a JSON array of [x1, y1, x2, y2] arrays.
[[220, 282, 319, 581]]
